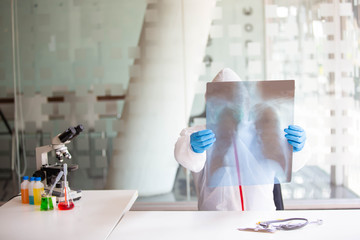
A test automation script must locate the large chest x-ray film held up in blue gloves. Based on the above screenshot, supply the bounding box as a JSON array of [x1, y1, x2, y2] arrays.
[[204, 80, 294, 187]]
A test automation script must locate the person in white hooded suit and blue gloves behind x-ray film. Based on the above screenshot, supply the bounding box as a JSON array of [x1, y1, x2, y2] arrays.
[[174, 68, 306, 211]]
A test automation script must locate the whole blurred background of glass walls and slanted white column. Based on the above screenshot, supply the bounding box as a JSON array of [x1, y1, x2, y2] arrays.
[[0, 0, 360, 209]]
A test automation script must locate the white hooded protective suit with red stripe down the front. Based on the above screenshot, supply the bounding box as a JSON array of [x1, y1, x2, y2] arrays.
[[174, 68, 306, 211]]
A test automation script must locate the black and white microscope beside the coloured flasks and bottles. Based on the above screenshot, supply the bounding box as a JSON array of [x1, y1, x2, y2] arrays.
[[33, 124, 84, 201]]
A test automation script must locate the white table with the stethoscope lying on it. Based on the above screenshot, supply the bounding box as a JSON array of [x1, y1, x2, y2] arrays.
[[109, 210, 360, 240]]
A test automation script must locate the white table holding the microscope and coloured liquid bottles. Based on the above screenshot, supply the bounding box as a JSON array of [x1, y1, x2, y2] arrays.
[[0, 190, 138, 240]]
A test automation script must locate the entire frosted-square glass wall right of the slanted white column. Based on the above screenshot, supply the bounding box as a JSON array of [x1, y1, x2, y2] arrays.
[[186, 0, 360, 208]]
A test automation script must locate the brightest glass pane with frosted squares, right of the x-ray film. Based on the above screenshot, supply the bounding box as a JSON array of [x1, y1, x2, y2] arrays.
[[265, 0, 360, 202]]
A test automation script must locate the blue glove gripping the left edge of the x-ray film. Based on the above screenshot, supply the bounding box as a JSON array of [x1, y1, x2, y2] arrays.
[[190, 129, 216, 153]]
